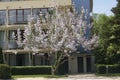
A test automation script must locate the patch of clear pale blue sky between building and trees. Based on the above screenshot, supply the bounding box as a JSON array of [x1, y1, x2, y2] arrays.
[[93, 0, 117, 16]]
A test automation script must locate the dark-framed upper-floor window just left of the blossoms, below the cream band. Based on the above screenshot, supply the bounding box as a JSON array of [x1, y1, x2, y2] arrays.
[[9, 9, 31, 24]]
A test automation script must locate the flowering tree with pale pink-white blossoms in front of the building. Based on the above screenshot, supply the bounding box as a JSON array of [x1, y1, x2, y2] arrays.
[[13, 3, 98, 74]]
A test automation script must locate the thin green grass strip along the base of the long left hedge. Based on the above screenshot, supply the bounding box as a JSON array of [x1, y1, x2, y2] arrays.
[[12, 75, 67, 78]]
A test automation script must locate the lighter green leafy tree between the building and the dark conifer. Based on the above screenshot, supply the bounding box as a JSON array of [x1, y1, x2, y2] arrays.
[[92, 14, 113, 64]]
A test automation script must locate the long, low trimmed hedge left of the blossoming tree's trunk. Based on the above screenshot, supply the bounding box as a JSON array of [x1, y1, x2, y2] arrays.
[[11, 66, 51, 75]]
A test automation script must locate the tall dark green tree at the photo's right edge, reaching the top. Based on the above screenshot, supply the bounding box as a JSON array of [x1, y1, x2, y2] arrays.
[[107, 0, 120, 63]]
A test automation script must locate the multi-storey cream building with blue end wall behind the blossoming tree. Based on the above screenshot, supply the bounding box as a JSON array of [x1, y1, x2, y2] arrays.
[[0, 0, 94, 73]]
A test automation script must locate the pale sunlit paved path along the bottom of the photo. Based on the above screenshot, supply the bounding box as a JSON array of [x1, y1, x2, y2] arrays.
[[15, 74, 120, 80]]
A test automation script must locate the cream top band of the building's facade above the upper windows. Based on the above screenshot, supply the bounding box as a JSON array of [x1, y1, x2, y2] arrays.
[[0, 0, 71, 10]]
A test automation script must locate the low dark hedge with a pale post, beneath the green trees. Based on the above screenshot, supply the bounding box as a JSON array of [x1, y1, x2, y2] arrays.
[[97, 64, 120, 74]]
